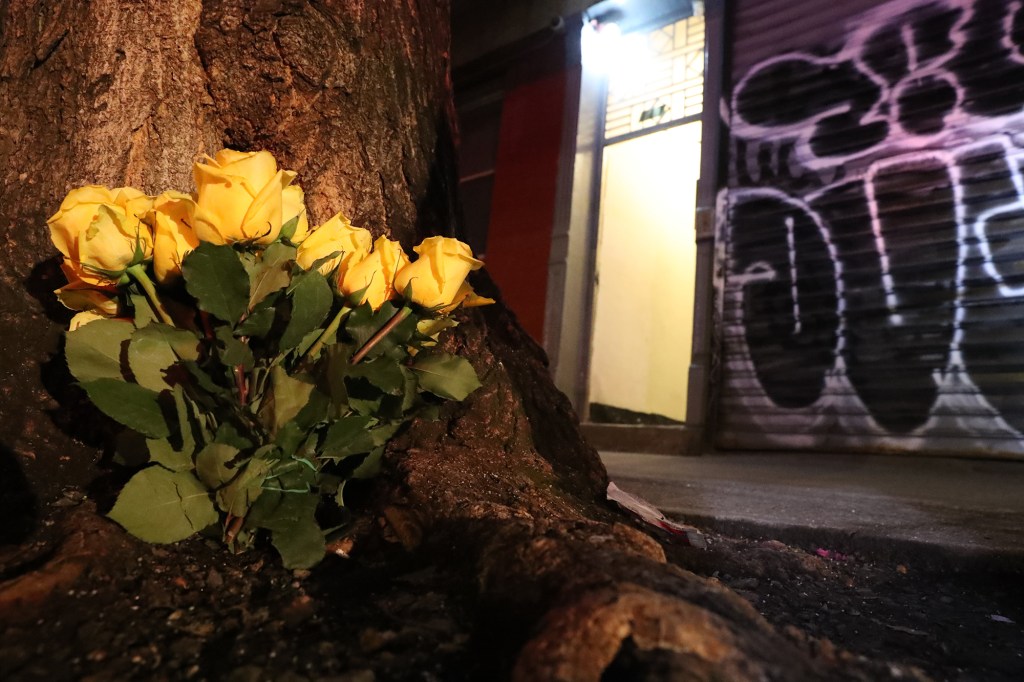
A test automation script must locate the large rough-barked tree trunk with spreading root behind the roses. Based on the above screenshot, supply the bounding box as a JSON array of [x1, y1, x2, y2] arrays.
[[0, 0, 925, 680]]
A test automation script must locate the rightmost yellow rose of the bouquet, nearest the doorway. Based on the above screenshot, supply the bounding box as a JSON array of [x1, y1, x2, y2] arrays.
[[394, 237, 483, 308]]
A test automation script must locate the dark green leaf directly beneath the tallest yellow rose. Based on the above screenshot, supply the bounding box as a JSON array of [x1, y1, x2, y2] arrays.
[[181, 242, 249, 326]]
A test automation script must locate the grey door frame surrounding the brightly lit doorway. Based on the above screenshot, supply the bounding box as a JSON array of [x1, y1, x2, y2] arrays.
[[544, 0, 725, 455]]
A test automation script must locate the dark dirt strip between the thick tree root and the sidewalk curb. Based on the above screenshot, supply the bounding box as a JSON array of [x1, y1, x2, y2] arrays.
[[668, 534, 1024, 682]]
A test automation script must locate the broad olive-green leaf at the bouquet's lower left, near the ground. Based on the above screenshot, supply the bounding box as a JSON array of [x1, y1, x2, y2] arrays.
[[109, 467, 218, 543]]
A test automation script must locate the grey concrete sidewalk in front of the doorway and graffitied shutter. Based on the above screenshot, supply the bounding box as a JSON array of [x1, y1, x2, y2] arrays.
[[601, 453, 1024, 569]]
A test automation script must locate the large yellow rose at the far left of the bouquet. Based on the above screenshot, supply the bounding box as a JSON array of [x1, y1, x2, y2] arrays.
[[46, 185, 153, 286]]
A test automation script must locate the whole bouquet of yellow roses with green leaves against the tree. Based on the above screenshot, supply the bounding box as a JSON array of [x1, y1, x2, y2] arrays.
[[48, 150, 493, 567]]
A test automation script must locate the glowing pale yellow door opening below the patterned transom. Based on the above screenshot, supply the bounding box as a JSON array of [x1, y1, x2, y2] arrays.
[[589, 121, 700, 424]]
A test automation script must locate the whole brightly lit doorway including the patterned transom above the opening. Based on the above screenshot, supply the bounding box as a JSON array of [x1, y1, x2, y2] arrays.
[[582, 13, 705, 426]]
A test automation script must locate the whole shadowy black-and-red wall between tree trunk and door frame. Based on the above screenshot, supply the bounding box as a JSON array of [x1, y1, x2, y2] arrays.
[[454, 23, 582, 342]]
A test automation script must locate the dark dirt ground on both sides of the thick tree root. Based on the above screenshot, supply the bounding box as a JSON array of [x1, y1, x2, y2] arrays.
[[0, 491, 1024, 682]]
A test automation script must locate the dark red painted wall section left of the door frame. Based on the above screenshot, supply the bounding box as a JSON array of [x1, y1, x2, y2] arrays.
[[486, 71, 565, 342]]
